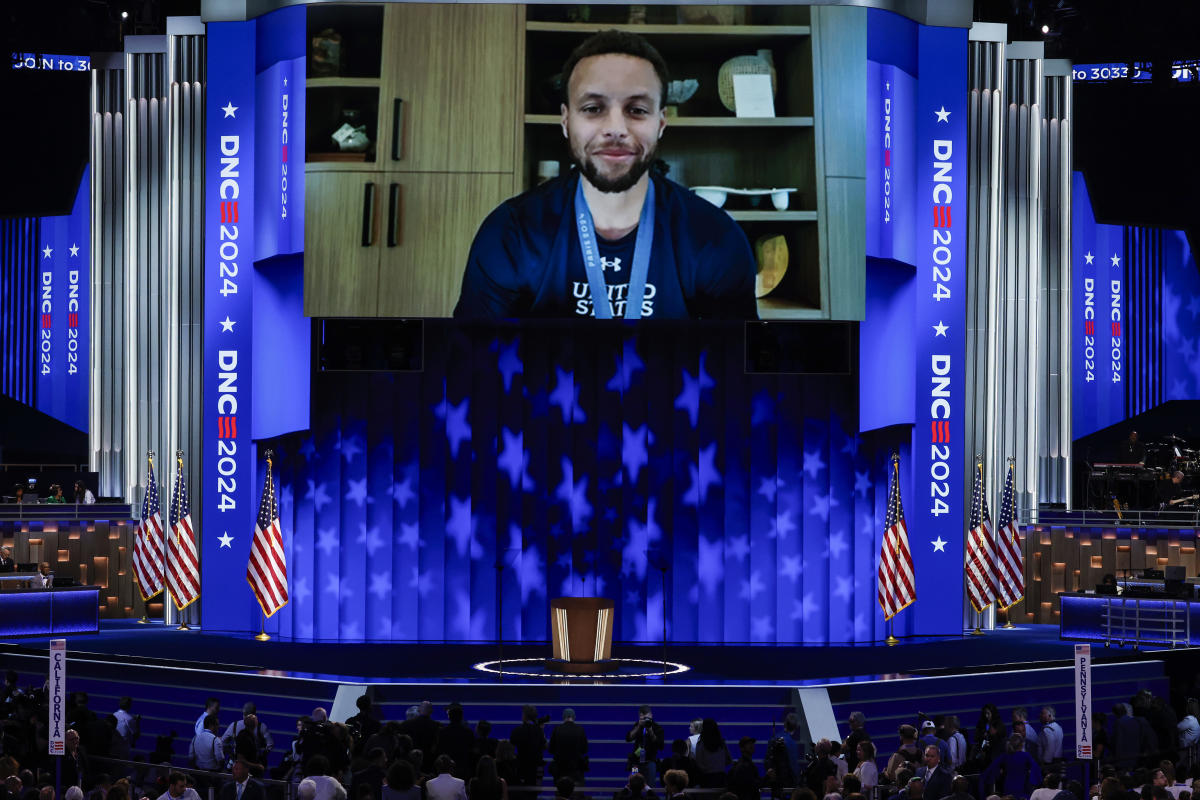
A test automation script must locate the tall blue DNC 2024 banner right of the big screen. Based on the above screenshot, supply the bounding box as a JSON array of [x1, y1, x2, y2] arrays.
[[904, 26, 968, 634]]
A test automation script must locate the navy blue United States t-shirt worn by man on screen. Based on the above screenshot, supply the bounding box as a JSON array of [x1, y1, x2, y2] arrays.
[[454, 170, 757, 319]]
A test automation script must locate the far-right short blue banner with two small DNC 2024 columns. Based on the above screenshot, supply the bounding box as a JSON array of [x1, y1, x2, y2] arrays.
[[1072, 173, 1127, 439]]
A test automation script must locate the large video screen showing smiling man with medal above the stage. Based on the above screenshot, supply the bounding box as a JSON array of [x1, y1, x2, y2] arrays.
[[293, 4, 822, 320]]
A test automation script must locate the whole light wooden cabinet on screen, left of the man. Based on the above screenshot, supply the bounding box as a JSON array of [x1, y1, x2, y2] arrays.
[[305, 2, 524, 317]]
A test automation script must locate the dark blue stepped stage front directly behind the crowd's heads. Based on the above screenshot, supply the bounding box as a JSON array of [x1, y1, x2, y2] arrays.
[[4, 652, 1168, 796]]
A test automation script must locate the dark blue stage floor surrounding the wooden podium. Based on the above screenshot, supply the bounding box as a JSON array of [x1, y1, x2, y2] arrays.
[[7, 620, 1200, 686]]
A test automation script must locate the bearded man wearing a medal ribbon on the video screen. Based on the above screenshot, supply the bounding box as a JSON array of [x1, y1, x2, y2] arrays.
[[455, 30, 756, 319]]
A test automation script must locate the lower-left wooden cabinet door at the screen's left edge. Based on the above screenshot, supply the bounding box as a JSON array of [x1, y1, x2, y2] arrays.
[[304, 170, 385, 317]]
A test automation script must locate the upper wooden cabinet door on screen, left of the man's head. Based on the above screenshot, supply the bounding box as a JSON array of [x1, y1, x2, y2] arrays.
[[379, 2, 523, 173]]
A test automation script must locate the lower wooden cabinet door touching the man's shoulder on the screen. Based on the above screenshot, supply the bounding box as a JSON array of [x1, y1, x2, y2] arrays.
[[379, 173, 512, 317]]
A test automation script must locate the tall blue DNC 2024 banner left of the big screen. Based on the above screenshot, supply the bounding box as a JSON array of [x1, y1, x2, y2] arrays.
[[200, 20, 258, 630]]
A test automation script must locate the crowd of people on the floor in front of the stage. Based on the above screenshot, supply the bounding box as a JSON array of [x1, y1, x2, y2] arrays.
[[0, 673, 1200, 800]]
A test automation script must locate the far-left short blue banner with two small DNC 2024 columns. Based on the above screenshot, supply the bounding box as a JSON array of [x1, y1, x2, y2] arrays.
[[36, 169, 91, 431]]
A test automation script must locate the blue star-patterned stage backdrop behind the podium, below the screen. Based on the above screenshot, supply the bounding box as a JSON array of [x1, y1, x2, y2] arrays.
[[246, 320, 910, 643]]
